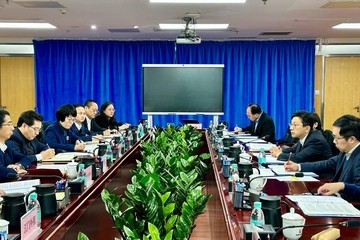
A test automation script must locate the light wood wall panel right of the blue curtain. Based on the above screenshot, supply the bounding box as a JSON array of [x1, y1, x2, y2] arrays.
[[324, 56, 360, 129]]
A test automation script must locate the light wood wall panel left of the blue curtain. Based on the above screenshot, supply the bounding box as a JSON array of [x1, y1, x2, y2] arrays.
[[0, 56, 35, 125]]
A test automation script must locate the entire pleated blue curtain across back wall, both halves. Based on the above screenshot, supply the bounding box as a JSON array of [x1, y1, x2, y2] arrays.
[[34, 40, 315, 138]]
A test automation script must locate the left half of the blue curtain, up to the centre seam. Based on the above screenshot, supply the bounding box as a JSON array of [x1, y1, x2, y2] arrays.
[[33, 40, 175, 125]]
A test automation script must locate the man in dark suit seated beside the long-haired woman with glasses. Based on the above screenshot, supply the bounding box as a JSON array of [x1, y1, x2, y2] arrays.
[[83, 99, 111, 136]]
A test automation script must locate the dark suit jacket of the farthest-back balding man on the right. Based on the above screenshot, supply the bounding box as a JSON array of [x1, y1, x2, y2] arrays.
[[242, 112, 275, 143]]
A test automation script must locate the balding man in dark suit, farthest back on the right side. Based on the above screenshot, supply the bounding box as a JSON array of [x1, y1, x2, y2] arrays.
[[235, 103, 275, 143]]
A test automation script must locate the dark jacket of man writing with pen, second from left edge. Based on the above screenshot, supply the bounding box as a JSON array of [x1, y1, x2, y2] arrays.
[[5, 128, 48, 162]]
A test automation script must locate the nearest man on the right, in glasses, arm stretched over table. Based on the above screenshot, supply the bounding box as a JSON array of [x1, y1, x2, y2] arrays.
[[284, 115, 360, 199]]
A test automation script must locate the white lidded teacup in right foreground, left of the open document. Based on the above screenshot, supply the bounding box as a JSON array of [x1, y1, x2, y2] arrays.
[[281, 208, 305, 240]]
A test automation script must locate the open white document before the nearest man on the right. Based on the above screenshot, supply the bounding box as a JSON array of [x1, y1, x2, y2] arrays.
[[286, 195, 360, 217]]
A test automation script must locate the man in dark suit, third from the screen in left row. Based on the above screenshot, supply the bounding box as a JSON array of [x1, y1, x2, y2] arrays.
[[70, 104, 102, 142]]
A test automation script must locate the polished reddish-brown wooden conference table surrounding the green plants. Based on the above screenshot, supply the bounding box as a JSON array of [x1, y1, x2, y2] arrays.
[[9, 131, 360, 240]]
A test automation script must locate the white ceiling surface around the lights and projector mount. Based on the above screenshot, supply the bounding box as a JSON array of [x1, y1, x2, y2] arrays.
[[0, 0, 360, 43]]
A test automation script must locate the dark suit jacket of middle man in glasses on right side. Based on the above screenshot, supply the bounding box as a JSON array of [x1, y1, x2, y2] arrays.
[[278, 130, 332, 163]]
